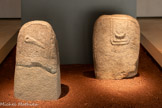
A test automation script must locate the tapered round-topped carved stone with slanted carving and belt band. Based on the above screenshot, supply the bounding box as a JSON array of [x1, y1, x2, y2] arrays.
[[14, 21, 61, 100]]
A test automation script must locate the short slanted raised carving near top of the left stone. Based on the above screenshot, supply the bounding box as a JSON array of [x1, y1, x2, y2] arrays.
[[25, 35, 45, 49]]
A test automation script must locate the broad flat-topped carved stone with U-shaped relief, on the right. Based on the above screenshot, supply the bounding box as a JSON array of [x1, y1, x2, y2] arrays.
[[93, 15, 140, 79]]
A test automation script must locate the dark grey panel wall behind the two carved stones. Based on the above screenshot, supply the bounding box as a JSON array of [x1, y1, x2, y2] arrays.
[[22, 0, 136, 64]]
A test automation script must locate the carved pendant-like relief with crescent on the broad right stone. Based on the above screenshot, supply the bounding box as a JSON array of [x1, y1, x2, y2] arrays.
[[111, 19, 129, 45]]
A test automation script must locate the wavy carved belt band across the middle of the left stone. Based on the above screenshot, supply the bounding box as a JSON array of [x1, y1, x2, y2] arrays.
[[16, 62, 56, 74]]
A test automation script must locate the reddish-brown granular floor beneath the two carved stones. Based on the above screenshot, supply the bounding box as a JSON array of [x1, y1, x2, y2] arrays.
[[0, 47, 162, 108]]
